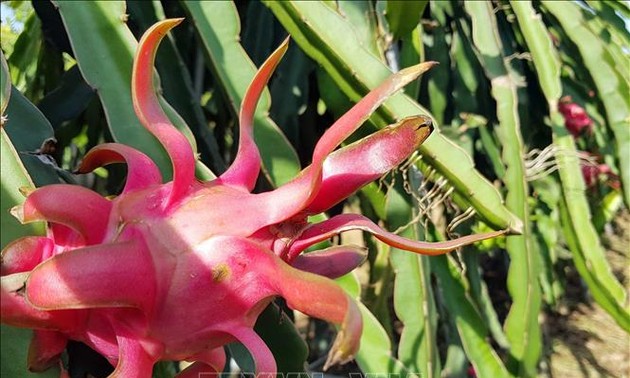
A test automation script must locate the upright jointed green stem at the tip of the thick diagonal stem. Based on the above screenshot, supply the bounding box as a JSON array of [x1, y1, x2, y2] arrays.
[[466, 2, 541, 376]]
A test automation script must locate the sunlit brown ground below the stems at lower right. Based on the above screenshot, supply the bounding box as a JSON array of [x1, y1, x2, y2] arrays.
[[542, 210, 630, 378]]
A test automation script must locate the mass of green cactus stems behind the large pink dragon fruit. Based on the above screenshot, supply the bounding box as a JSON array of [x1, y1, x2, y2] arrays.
[[0, 0, 630, 377]]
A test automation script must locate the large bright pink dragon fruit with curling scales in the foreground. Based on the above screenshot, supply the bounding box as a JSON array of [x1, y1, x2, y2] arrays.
[[1, 19, 504, 377]]
